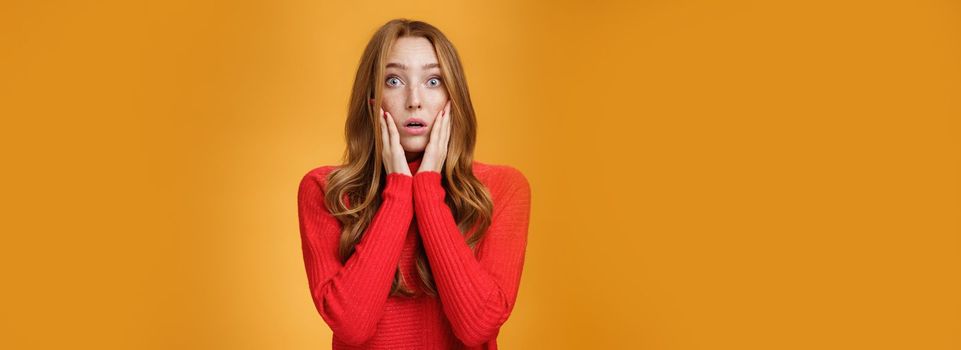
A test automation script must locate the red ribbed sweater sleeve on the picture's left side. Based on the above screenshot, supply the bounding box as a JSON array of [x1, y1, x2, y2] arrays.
[[297, 172, 413, 345]]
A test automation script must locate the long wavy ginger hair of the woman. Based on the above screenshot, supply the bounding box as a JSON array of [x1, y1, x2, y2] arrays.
[[324, 18, 493, 296]]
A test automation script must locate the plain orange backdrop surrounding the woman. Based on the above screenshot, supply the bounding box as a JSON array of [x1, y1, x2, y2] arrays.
[[0, 0, 961, 350]]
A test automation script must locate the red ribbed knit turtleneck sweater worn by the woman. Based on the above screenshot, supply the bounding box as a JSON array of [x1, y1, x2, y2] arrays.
[[297, 158, 531, 350]]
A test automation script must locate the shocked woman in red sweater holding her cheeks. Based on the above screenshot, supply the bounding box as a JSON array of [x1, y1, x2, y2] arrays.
[[298, 19, 530, 349]]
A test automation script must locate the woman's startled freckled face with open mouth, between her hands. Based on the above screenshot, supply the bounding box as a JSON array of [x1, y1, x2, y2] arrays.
[[382, 37, 447, 155]]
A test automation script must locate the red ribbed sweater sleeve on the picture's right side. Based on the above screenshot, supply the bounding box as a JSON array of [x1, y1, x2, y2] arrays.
[[413, 167, 530, 346]]
